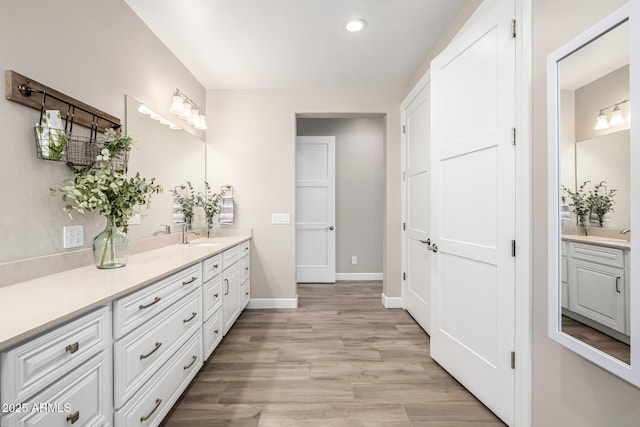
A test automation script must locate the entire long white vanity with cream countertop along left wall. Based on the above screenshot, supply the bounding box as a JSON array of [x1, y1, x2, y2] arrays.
[[0, 233, 251, 427]]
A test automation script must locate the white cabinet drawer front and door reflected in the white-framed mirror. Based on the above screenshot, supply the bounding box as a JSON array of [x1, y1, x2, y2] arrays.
[[568, 242, 629, 335]]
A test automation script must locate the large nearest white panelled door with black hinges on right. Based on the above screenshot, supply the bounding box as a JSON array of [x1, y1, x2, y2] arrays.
[[430, 0, 516, 424]]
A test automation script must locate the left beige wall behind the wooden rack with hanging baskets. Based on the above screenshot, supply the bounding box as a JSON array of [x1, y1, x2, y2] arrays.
[[0, 0, 205, 268]]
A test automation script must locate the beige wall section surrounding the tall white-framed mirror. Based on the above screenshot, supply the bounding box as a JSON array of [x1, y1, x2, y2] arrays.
[[532, 0, 640, 427]]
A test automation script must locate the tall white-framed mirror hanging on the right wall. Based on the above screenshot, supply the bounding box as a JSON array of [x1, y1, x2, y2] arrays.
[[547, 0, 640, 386]]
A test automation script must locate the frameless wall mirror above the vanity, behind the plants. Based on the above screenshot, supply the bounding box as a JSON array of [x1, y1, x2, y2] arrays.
[[126, 95, 206, 239]]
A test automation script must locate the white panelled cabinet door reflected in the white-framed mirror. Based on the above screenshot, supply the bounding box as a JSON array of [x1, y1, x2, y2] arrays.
[[569, 259, 626, 333]]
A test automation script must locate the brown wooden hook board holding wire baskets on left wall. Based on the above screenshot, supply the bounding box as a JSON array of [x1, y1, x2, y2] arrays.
[[5, 70, 121, 132]]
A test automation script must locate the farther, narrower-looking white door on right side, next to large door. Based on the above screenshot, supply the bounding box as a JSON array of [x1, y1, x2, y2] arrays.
[[403, 81, 431, 333]]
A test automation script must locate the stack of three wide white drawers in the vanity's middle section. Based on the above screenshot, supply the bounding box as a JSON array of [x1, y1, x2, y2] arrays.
[[113, 263, 202, 426]]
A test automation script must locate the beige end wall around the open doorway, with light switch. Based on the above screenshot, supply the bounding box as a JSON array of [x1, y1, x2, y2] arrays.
[[207, 89, 400, 298]]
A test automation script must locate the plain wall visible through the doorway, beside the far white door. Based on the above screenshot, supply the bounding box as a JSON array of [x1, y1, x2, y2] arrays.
[[297, 117, 384, 273]]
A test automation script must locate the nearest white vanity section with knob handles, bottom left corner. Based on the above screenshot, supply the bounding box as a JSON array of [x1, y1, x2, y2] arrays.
[[0, 306, 113, 427]]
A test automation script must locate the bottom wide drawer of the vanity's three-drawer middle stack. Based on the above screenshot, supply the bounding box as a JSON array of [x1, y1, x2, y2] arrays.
[[114, 333, 202, 427]]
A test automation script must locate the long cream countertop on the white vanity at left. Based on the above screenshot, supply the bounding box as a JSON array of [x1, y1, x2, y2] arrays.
[[0, 233, 251, 349]]
